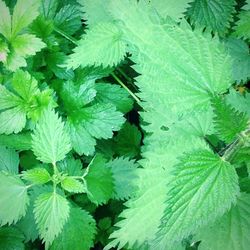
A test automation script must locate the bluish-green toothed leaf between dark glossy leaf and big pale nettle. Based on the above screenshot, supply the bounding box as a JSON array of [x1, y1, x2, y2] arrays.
[[106, 157, 138, 199]]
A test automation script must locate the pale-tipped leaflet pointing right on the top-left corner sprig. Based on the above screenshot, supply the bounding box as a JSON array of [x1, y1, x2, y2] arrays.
[[11, 34, 45, 57]]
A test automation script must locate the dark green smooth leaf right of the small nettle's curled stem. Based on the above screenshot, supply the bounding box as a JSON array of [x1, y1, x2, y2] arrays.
[[85, 156, 114, 204]]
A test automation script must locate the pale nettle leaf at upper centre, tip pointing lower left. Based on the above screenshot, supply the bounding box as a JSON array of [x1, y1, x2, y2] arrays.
[[67, 23, 126, 69]]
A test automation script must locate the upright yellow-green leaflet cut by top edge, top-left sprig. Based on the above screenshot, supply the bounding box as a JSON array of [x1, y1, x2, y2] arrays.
[[12, 0, 40, 37]]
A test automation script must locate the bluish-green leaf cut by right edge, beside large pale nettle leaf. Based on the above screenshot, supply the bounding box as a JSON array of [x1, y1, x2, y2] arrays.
[[226, 38, 250, 83]]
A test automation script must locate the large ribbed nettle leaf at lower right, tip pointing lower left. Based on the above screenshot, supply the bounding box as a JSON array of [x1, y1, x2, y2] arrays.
[[154, 150, 239, 249]]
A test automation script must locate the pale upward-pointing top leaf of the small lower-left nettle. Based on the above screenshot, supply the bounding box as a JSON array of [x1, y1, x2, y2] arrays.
[[32, 109, 71, 164]]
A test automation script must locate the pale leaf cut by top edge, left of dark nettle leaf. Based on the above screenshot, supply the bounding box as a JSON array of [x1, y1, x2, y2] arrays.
[[149, 0, 193, 21]]
